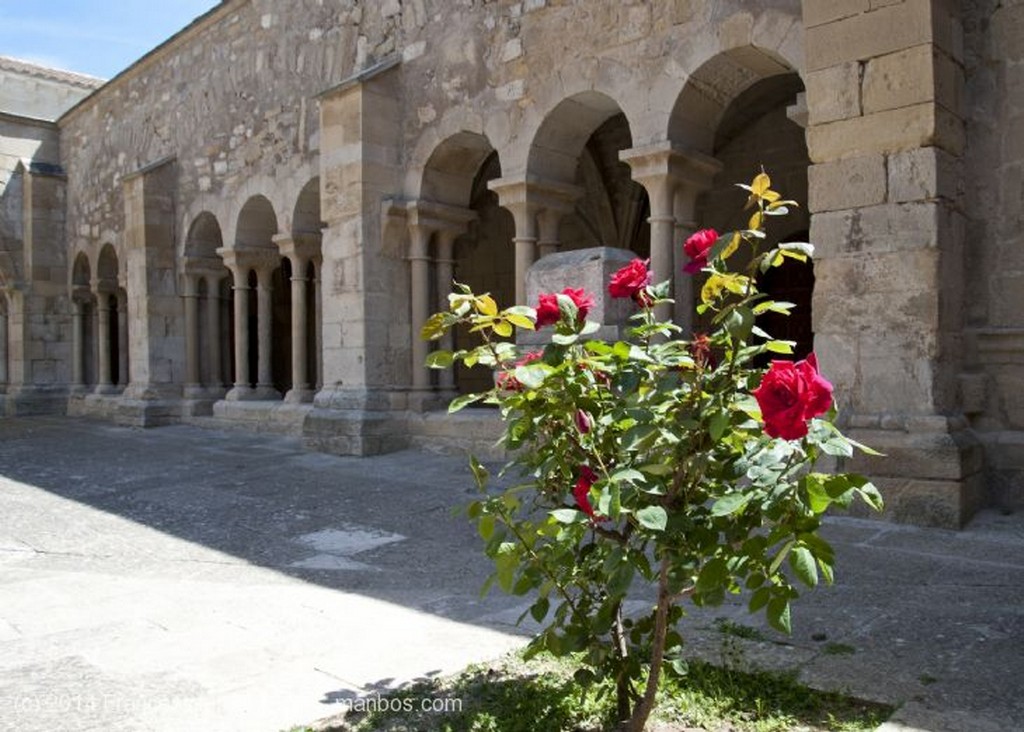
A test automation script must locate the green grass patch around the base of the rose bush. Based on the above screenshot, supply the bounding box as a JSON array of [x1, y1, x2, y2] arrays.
[[293, 654, 893, 732]]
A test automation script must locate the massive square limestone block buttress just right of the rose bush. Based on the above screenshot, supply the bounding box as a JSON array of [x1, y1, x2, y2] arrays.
[[803, 0, 974, 526]]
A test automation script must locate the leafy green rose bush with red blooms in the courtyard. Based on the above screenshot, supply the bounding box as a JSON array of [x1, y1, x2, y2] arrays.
[[423, 173, 882, 730]]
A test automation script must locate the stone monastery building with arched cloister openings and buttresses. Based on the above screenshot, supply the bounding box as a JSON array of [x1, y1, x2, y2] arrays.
[[0, 0, 1024, 526]]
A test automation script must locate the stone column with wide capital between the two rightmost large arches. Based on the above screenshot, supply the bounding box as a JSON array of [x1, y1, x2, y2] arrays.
[[618, 142, 722, 319]]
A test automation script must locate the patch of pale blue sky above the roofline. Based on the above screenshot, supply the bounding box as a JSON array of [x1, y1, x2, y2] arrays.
[[0, 0, 219, 79]]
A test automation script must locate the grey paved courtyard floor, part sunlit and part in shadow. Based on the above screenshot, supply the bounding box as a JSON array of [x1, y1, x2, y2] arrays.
[[0, 419, 1024, 732]]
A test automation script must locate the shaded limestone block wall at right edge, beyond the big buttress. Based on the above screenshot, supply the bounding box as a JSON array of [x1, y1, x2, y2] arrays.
[[959, 0, 1024, 507]]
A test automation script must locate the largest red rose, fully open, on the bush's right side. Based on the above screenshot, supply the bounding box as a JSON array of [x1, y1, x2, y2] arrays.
[[754, 353, 833, 439]]
